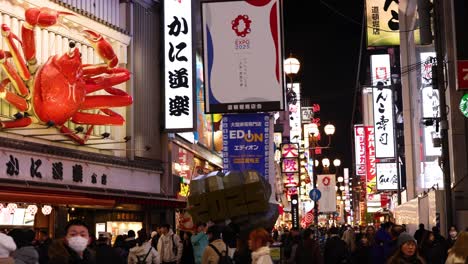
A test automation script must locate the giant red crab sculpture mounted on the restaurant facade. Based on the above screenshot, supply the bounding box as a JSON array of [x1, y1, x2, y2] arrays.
[[0, 7, 132, 145]]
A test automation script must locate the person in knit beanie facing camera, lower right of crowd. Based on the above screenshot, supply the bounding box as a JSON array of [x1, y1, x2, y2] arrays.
[[387, 233, 426, 264]]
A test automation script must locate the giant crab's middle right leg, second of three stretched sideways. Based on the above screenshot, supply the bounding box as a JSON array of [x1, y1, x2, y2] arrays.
[[80, 87, 133, 110]]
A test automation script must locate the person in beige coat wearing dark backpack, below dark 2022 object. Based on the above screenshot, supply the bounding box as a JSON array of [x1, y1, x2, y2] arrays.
[[202, 225, 234, 264]]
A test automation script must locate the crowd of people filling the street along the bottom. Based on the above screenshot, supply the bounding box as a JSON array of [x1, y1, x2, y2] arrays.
[[0, 220, 468, 264]]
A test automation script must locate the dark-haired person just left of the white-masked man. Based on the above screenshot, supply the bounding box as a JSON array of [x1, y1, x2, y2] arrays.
[[8, 229, 39, 264]]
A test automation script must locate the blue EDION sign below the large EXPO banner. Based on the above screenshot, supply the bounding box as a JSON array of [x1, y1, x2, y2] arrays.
[[223, 114, 270, 179]]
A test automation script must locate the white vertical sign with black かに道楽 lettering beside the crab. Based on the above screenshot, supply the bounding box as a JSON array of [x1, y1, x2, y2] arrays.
[[164, 0, 195, 131]]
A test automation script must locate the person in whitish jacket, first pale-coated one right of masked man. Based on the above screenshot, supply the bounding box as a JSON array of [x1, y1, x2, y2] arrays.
[[127, 229, 161, 264]]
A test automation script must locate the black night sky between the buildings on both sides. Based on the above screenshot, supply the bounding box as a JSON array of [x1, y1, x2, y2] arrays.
[[283, 0, 365, 168]]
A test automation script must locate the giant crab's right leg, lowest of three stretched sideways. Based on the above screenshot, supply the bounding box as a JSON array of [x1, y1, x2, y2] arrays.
[[72, 108, 125, 126]]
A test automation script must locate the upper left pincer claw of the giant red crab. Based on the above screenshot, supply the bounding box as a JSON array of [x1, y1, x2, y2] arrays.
[[25, 7, 74, 27]]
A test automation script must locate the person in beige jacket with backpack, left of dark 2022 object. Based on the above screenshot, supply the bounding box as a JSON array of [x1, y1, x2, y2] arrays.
[[158, 224, 183, 264]]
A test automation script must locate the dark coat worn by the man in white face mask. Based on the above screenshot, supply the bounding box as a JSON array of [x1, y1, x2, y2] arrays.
[[49, 239, 96, 264]]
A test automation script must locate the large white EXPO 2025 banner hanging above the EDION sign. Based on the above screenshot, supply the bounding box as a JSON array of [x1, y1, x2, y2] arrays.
[[202, 0, 285, 113]]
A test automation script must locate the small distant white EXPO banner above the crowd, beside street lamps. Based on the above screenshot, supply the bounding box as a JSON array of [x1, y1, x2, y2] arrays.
[[317, 174, 336, 213]]
